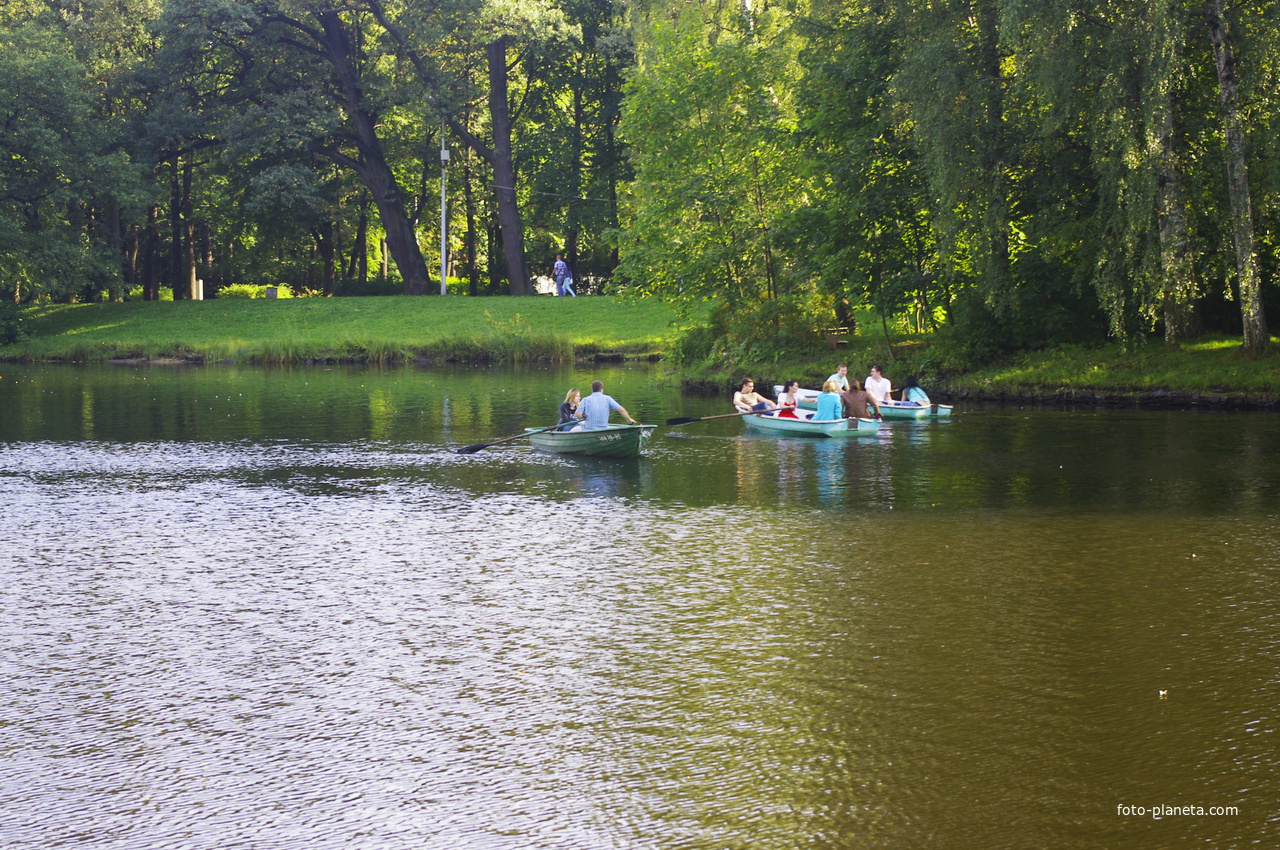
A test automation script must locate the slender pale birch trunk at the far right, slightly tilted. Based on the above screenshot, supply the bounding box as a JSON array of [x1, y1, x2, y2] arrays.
[[1204, 0, 1271, 355]]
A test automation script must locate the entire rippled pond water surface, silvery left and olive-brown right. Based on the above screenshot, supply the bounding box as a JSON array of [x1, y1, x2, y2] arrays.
[[0, 365, 1280, 850]]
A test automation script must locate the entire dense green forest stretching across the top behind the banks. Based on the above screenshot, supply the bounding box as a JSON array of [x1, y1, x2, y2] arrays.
[[0, 0, 1280, 355]]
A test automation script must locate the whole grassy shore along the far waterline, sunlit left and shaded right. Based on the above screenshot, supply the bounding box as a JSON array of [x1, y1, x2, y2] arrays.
[[0, 296, 1280, 407]]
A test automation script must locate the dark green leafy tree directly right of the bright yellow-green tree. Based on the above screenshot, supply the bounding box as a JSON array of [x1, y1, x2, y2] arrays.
[[787, 3, 951, 329]]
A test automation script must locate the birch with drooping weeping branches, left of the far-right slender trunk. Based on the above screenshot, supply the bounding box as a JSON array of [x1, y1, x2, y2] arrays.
[[1015, 3, 1201, 346]]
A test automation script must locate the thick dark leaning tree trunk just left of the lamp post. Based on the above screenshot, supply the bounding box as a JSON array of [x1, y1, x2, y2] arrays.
[[319, 10, 431, 296]]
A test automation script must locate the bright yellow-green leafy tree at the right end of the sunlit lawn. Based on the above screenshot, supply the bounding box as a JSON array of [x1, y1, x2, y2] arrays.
[[620, 3, 799, 302]]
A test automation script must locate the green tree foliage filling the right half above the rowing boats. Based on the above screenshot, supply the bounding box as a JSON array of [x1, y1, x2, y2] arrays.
[[622, 0, 1277, 353]]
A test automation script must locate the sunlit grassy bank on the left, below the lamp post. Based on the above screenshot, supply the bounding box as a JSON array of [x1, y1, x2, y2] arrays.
[[0, 296, 675, 362]]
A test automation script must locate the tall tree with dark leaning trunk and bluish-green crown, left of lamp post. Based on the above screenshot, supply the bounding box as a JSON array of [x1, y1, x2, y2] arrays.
[[153, 0, 431, 294]]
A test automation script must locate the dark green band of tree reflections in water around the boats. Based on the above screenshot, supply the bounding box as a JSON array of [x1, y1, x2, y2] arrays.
[[17, 365, 1280, 513]]
